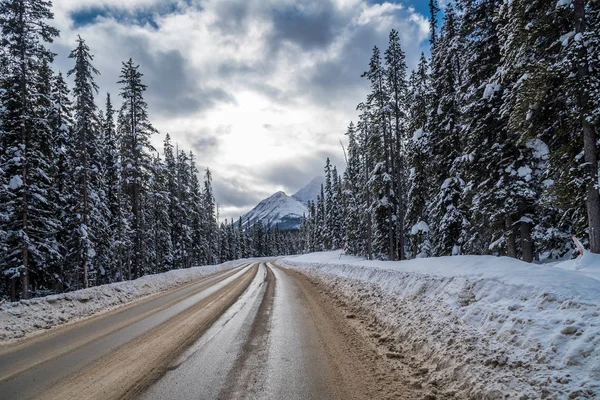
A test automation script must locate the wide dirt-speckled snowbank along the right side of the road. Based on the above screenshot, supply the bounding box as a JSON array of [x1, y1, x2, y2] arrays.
[[278, 251, 600, 399]]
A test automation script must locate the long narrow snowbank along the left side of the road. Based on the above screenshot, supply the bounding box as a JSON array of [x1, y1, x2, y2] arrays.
[[0, 261, 247, 345]]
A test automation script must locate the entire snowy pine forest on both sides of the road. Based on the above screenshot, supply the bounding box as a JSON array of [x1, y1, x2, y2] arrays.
[[0, 0, 600, 300]]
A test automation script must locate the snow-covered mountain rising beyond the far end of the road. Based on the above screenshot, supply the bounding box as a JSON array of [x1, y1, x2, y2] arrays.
[[242, 177, 324, 230]]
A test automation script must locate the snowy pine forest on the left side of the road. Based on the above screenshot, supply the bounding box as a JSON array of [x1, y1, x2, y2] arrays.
[[0, 0, 298, 300]]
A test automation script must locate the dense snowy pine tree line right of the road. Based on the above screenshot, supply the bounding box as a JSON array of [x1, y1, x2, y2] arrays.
[[302, 0, 600, 262]]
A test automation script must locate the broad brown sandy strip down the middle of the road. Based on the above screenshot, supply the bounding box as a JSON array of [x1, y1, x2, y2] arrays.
[[39, 264, 257, 400]]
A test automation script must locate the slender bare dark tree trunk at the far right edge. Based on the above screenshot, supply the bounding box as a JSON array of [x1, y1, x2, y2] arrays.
[[573, 0, 600, 253]]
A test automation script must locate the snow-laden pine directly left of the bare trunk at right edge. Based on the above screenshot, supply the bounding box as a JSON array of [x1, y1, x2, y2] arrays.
[[500, 1, 588, 254]]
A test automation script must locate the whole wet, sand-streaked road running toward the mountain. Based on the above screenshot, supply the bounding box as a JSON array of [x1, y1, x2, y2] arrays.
[[0, 262, 420, 400]]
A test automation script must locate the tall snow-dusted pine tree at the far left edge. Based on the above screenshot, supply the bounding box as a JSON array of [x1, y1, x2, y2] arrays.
[[0, 0, 58, 299]]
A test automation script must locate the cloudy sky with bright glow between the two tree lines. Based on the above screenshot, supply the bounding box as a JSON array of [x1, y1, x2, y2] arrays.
[[47, 0, 428, 218]]
